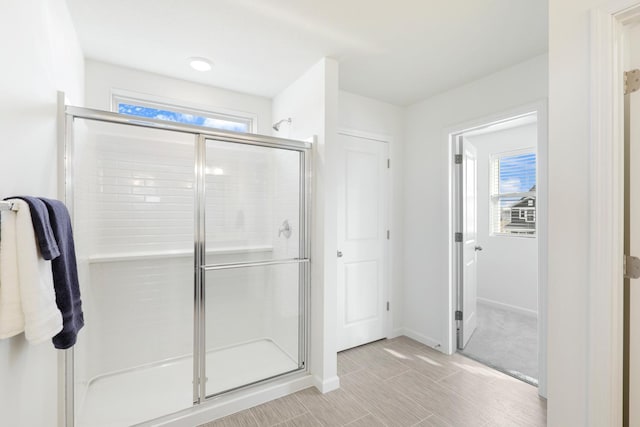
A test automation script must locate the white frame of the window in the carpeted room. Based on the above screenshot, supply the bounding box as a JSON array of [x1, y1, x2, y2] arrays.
[[489, 147, 538, 238]]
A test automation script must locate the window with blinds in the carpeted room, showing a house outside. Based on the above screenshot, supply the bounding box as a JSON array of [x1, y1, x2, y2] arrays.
[[490, 150, 536, 236]]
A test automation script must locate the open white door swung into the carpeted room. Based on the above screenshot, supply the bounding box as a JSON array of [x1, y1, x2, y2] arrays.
[[462, 144, 478, 348]]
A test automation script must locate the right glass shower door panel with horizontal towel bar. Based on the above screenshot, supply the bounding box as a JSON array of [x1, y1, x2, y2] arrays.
[[201, 139, 307, 396]]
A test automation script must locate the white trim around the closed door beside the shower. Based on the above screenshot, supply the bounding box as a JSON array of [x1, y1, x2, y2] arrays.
[[336, 128, 392, 344]]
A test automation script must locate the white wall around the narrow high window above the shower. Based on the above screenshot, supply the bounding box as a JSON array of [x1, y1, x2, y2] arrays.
[[86, 60, 273, 135]]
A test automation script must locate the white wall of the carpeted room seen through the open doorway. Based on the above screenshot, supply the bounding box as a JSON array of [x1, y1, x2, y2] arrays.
[[465, 123, 538, 315]]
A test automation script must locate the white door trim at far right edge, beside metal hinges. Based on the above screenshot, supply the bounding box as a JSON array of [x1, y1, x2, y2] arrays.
[[586, 0, 640, 426]]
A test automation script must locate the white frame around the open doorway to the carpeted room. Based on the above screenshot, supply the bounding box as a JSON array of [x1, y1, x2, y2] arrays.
[[443, 99, 548, 397]]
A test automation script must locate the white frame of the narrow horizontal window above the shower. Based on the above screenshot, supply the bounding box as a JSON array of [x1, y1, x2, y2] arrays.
[[111, 89, 258, 134]]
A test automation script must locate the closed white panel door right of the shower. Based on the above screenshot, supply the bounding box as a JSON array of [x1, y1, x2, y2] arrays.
[[337, 135, 388, 351]]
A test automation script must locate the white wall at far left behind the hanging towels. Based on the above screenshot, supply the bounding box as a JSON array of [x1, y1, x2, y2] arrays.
[[0, 0, 84, 427]]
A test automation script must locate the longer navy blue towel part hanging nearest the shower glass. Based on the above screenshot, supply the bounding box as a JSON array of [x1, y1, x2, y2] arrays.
[[40, 197, 84, 349]]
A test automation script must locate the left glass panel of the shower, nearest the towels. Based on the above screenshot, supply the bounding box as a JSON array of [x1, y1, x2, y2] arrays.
[[68, 118, 196, 427]]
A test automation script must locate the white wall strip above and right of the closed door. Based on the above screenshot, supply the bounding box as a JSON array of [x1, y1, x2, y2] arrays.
[[338, 90, 405, 336]]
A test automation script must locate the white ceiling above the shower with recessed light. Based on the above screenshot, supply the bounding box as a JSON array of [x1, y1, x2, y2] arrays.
[[67, 0, 547, 105]]
